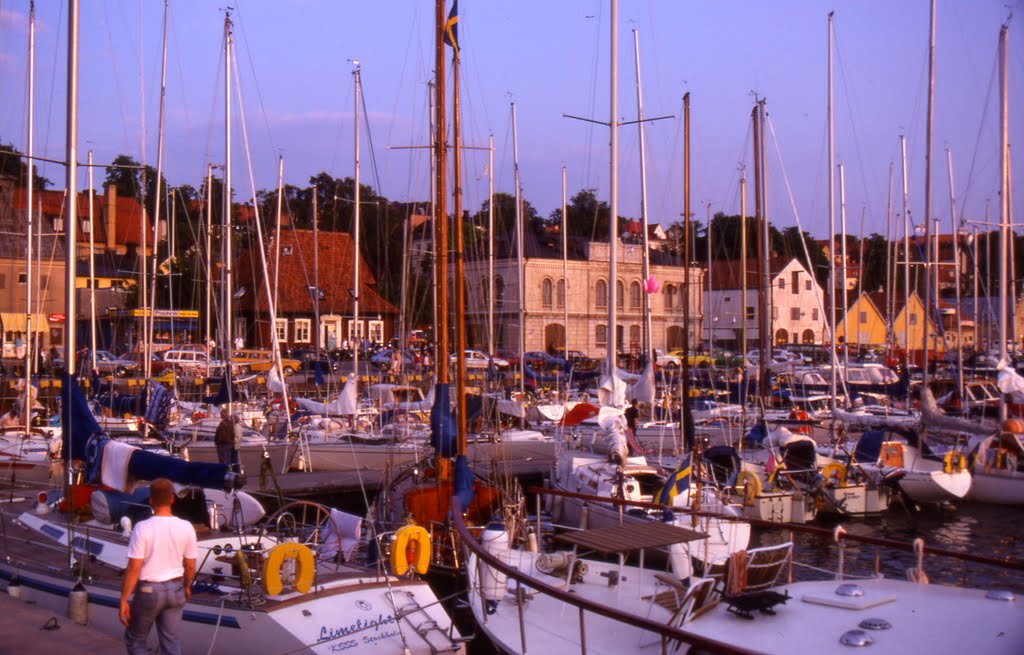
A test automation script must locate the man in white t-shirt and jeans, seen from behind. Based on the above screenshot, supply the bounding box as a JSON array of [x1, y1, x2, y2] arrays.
[[120, 478, 199, 655]]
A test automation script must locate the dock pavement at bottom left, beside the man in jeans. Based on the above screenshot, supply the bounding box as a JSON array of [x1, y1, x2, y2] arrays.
[[0, 593, 125, 655]]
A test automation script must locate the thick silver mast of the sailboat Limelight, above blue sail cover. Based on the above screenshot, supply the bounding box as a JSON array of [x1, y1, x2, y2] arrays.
[[60, 0, 79, 484]]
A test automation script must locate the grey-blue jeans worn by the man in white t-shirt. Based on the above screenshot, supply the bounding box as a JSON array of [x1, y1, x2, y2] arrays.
[[125, 578, 185, 655]]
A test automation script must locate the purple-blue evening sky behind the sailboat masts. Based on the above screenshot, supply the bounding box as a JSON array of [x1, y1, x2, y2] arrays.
[[0, 0, 1024, 237]]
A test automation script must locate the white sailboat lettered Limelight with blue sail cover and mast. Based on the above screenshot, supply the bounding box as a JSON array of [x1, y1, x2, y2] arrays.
[[0, 6, 464, 655]]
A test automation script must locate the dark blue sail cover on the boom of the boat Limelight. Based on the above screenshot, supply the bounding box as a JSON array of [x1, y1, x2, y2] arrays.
[[60, 374, 236, 489]]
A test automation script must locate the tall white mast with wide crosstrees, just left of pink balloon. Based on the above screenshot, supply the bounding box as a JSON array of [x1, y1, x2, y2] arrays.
[[605, 0, 618, 381]]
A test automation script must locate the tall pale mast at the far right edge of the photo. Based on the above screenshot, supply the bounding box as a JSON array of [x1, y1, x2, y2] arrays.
[[999, 24, 1014, 421]]
